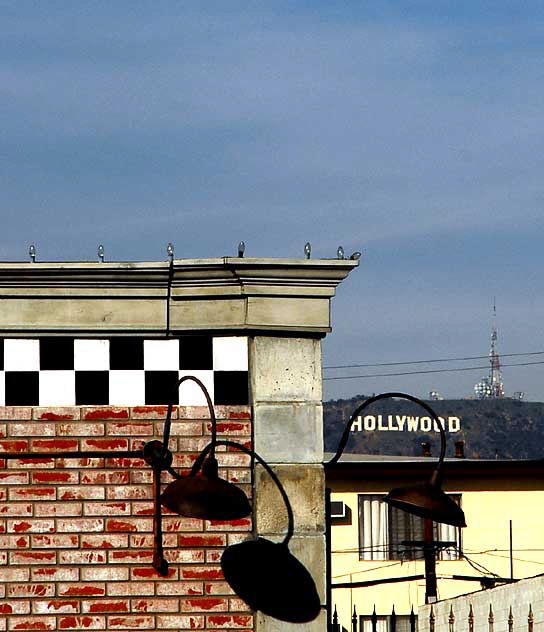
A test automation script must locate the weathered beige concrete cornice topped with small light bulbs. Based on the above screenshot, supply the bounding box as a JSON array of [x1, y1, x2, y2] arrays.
[[0, 257, 358, 335]]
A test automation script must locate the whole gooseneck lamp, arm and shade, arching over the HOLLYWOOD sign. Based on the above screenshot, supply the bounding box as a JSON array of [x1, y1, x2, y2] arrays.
[[327, 392, 467, 527]]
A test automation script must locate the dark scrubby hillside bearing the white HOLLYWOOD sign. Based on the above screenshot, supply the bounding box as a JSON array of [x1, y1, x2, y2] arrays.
[[324, 395, 544, 459]]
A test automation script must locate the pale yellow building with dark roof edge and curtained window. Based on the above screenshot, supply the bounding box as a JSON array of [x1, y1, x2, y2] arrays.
[[326, 454, 544, 632]]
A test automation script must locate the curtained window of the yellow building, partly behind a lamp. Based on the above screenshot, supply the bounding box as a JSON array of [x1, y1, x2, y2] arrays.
[[359, 494, 461, 560]]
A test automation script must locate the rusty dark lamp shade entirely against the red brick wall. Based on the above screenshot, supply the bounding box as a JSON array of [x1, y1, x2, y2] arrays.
[[157, 457, 251, 520]]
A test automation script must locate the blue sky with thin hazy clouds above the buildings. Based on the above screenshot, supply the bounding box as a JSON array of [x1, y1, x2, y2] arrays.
[[0, 0, 544, 401]]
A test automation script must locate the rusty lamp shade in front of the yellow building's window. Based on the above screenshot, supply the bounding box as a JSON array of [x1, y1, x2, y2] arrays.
[[384, 483, 467, 527]]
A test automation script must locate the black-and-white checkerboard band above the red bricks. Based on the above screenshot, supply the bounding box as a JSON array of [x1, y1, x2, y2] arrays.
[[0, 335, 248, 406]]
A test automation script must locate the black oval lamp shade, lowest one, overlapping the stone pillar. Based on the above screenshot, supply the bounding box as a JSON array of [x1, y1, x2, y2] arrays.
[[221, 538, 321, 623]]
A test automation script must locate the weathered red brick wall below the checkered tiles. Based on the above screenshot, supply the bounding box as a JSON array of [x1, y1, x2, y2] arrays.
[[0, 406, 253, 630]]
